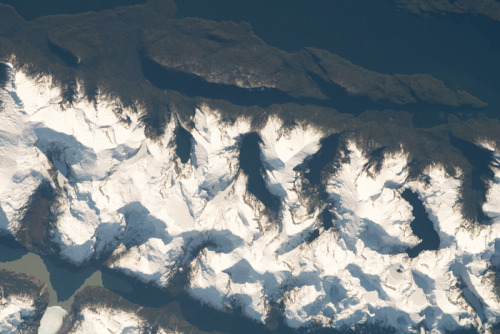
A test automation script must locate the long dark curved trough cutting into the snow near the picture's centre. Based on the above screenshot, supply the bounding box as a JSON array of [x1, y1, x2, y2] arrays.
[[239, 132, 281, 211]]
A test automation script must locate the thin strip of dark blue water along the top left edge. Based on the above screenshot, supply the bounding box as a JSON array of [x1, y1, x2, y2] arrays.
[[0, 0, 146, 21]]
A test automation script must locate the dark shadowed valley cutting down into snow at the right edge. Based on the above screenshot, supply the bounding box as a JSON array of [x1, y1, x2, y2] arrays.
[[450, 135, 499, 224]]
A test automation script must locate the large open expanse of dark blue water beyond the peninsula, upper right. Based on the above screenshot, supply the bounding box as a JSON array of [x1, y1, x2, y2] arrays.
[[176, 0, 500, 113]]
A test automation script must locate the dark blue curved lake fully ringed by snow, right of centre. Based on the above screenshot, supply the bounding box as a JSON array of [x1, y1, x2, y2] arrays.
[[401, 189, 440, 258]]
